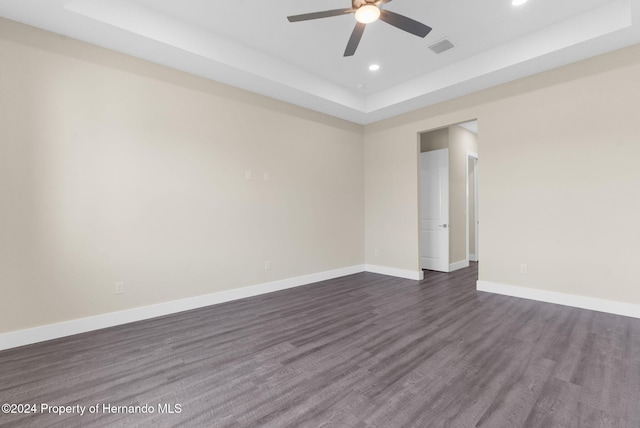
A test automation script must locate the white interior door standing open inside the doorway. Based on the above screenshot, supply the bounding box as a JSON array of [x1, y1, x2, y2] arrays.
[[420, 149, 449, 272]]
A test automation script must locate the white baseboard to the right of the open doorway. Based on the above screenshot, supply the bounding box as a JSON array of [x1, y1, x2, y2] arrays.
[[476, 281, 640, 318]]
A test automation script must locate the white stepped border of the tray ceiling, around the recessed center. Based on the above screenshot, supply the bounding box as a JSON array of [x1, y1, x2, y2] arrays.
[[0, 0, 640, 124]]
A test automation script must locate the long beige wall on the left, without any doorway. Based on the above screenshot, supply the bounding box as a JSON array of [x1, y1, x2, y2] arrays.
[[0, 20, 362, 333]]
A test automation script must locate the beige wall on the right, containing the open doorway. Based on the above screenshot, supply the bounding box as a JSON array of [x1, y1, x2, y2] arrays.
[[365, 41, 640, 304]]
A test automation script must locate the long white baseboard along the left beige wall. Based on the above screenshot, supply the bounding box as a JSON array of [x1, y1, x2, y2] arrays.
[[0, 265, 365, 350]]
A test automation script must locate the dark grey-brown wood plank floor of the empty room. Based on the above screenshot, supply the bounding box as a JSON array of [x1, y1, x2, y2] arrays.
[[0, 264, 640, 428]]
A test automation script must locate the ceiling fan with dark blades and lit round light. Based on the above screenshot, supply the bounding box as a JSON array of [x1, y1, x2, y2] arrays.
[[287, 0, 431, 56]]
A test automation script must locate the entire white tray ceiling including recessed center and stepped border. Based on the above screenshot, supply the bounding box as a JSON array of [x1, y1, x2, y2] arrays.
[[0, 0, 640, 124]]
